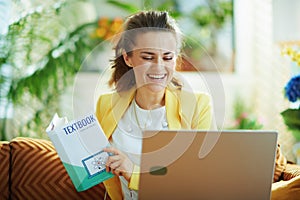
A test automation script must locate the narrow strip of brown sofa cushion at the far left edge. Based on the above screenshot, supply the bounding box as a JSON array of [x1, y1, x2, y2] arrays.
[[0, 142, 10, 199]]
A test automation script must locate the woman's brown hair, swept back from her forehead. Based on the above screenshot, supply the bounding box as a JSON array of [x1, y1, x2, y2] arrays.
[[109, 11, 182, 91]]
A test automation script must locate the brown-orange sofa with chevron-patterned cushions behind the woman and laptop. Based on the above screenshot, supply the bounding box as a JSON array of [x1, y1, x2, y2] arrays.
[[0, 137, 300, 200]]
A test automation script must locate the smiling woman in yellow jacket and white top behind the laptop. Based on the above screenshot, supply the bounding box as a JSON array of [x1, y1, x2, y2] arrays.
[[96, 11, 212, 199]]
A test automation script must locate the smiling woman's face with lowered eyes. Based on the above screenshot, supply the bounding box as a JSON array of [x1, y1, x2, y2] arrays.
[[123, 31, 177, 92]]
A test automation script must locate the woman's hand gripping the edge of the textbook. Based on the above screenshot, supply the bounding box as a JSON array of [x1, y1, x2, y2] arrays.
[[103, 147, 133, 182]]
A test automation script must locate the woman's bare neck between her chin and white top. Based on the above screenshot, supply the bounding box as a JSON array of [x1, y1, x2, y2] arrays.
[[135, 88, 165, 110]]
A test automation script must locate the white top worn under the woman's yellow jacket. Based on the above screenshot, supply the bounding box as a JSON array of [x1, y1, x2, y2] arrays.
[[111, 100, 168, 199]]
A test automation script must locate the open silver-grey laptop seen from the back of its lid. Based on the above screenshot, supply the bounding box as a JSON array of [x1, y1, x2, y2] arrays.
[[138, 130, 277, 200]]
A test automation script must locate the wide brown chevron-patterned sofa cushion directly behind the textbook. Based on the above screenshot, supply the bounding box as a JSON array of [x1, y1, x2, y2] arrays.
[[10, 137, 110, 199]]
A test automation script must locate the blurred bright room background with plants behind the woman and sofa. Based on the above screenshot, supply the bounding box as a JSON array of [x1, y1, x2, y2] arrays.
[[0, 0, 300, 161]]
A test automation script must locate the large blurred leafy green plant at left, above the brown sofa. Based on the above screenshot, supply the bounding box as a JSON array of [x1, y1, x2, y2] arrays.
[[0, 0, 99, 140]]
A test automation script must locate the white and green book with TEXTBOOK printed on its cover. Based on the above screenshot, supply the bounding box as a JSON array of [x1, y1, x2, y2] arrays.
[[46, 113, 114, 191]]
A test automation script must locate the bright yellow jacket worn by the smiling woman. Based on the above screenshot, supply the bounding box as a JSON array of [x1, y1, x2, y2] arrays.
[[96, 87, 212, 200]]
